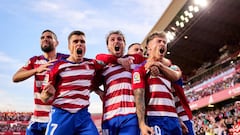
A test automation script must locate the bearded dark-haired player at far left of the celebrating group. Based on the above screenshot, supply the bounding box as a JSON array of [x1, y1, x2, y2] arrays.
[[13, 30, 68, 135]]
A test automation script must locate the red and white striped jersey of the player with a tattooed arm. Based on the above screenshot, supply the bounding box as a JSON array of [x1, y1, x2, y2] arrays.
[[132, 65, 178, 117]]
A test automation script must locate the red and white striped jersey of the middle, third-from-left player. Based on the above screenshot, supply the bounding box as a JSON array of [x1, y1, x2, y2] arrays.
[[97, 55, 145, 121]]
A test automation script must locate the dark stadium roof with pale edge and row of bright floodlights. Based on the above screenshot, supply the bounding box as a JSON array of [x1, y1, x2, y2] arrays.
[[142, 0, 240, 80]]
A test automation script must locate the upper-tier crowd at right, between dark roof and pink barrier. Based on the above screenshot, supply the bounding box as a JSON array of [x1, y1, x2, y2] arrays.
[[185, 61, 240, 102]]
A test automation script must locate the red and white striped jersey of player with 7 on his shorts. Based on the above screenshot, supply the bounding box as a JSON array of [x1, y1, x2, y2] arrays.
[[49, 59, 102, 113]]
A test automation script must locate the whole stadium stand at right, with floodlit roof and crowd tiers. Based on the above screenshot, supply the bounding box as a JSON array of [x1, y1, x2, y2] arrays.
[[142, 0, 240, 135]]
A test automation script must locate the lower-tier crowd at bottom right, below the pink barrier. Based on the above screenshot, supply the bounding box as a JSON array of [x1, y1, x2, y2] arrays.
[[193, 101, 240, 135]]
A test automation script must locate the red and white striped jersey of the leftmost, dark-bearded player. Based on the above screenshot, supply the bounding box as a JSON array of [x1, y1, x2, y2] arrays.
[[23, 53, 68, 122]]
